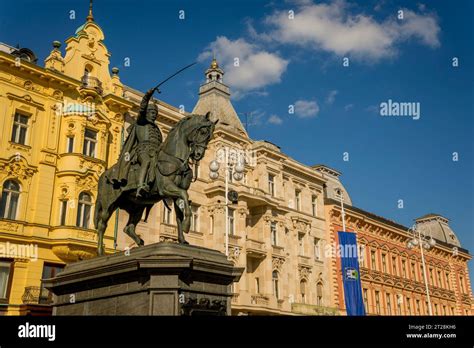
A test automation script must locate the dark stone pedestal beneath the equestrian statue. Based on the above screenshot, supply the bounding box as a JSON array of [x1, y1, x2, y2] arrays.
[[45, 243, 243, 315]]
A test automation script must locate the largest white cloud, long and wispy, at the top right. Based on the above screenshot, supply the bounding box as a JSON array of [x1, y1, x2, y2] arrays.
[[260, 0, 440, 60]]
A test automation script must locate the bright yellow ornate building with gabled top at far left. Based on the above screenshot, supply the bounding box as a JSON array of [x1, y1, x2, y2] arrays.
[[0, 8, 134, 314]]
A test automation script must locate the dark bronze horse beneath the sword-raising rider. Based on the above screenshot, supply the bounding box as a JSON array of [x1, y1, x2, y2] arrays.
[[94, 112, 217, 255]]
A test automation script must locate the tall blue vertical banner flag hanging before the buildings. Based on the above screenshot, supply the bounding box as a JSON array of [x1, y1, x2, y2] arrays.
[[338, 231, 365, 315]]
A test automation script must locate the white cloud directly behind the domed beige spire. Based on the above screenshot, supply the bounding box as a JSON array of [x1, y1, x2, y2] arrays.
[[198, 36, 288, 95]]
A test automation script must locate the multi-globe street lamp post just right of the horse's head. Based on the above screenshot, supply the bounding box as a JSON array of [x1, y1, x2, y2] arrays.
[[209, 147, 245, 256]]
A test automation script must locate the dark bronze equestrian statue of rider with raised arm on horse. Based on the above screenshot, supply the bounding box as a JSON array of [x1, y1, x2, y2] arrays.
[[94, 69, 217, 255]]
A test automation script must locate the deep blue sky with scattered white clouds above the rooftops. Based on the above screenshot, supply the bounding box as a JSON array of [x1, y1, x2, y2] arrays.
[[0, 0, 474, 279]]
